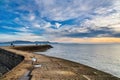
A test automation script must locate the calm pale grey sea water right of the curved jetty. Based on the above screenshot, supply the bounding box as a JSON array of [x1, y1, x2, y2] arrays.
[[37, 44, 120, 77]]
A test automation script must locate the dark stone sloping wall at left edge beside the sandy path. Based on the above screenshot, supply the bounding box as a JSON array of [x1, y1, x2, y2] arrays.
[[0, 49, 24, 76]]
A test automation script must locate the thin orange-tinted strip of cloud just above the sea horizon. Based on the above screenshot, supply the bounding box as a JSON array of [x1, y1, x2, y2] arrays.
[[55, 37, 120, 43]]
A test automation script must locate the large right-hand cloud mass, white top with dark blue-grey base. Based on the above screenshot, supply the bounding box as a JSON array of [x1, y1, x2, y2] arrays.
[[43, 1, 120, 38]]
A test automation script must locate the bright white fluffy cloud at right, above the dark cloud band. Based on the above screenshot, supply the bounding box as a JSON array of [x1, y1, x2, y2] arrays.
[[82, 0, 120, 33]]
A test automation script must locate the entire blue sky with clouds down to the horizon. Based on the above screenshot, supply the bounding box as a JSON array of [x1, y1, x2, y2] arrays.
[[0, 0, 120, 42]]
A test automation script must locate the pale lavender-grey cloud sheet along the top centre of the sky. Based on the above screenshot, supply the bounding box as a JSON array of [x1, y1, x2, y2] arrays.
[[36, 0, 112, 21]]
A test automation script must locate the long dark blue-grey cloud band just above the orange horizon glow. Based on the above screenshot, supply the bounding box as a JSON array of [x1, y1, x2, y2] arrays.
[[65, 27, 112, 38]]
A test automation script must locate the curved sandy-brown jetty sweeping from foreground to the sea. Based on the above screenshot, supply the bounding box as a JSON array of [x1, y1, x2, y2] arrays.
[[0, 45, 120, 80]]
